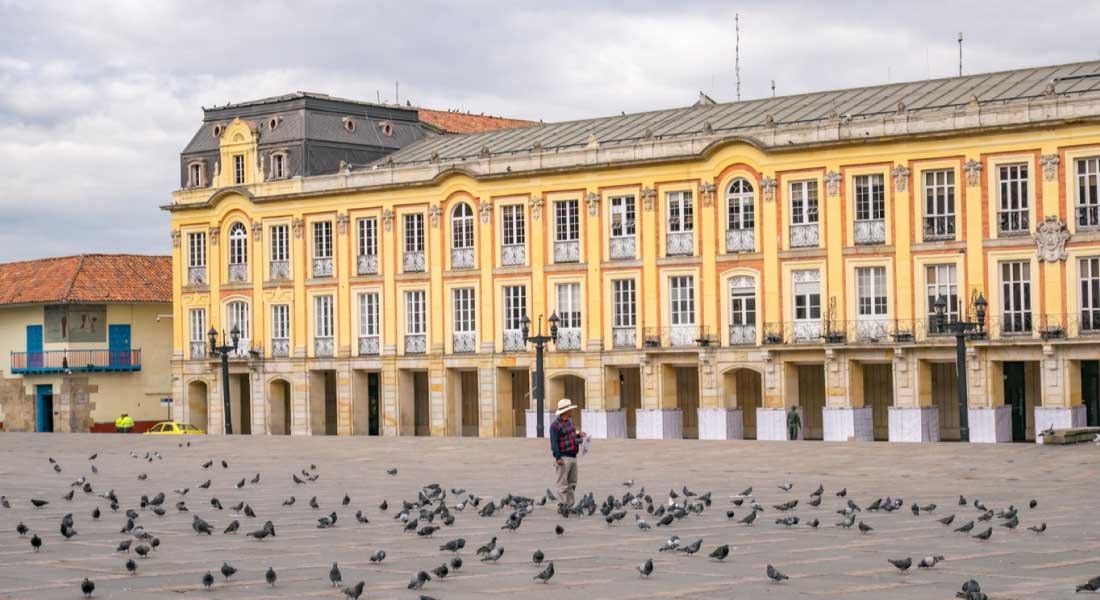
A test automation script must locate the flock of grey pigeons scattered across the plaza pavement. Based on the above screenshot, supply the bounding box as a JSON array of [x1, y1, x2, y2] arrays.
[[0, 441, 1100, 600]]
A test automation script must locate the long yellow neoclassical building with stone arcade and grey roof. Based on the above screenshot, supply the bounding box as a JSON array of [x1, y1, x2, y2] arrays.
[[165, 62, 1100, 441]]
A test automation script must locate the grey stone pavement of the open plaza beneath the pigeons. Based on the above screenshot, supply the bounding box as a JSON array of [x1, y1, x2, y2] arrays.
[[0, 434, 1100, 600]]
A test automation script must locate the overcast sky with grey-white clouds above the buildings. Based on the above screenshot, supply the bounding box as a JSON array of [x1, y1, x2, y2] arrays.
[[0, 0, 1100, 262]]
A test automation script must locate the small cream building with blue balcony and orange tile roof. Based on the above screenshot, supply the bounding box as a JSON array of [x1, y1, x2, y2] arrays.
[[0, 254, 173, 432]]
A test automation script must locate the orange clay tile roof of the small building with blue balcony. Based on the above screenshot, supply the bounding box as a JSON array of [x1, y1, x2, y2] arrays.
[[0, 254, 172, 305]]
